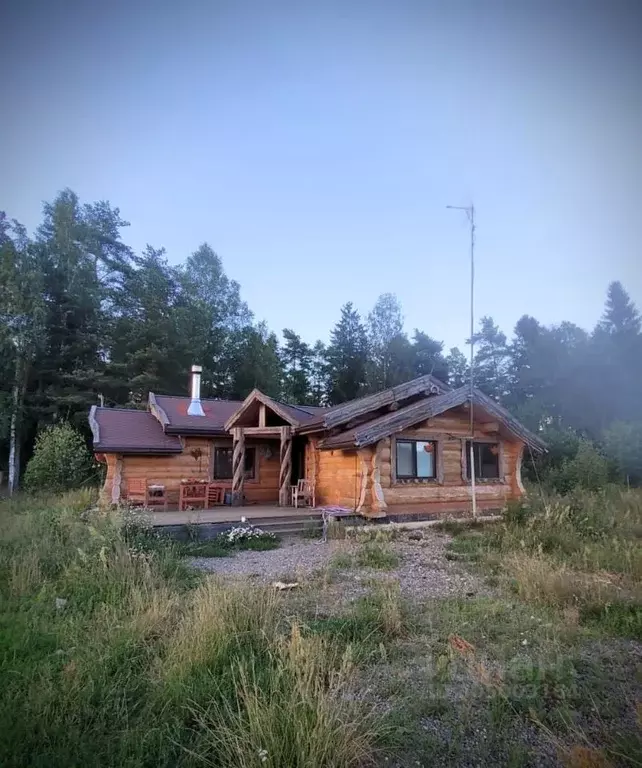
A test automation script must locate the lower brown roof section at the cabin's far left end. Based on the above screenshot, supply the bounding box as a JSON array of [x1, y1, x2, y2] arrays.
[[89, 406, 182, 453]]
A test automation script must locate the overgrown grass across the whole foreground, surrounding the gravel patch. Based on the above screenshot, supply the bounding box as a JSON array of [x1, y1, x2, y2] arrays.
[[0, 491, 642, 768]]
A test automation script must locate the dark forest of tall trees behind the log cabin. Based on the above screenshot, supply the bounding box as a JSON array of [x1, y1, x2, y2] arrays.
[[0, 190, 642, 492]]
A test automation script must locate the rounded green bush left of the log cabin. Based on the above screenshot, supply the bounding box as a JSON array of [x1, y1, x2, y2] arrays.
[[24, 423, 97, 493]]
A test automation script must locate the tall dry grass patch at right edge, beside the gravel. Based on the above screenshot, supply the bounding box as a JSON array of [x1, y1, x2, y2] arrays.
[[454, 488, 642, 637]]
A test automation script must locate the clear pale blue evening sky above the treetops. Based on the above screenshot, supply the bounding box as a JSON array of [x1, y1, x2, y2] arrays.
[[0, 0, 642, 349]]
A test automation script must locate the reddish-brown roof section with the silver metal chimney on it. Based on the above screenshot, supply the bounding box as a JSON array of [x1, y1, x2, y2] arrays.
[[149, 392, 241, 435]]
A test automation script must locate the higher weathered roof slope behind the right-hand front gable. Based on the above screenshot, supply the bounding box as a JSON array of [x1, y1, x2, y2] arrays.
[[296, 373, 450, 432]]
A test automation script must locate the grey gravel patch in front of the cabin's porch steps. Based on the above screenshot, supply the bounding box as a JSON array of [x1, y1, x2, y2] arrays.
[[190, 531, 492, 599]]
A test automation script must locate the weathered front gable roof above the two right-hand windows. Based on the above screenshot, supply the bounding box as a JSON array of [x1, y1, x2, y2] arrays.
[[319, 387, 546, 451]]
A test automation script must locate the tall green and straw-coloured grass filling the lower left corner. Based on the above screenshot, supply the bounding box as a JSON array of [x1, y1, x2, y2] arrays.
[[0, 492, 374, 768]]
